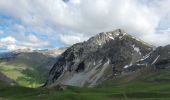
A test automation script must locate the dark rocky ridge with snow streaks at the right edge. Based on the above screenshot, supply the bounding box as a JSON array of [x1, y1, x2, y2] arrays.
[[125, 45, 170, 72]]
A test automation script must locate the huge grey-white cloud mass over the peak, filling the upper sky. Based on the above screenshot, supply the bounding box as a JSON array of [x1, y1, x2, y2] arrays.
[[0, 0, 170, 45]]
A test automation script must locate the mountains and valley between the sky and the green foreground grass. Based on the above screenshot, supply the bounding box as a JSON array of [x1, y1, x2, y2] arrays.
[[0, 29, 170, 87]]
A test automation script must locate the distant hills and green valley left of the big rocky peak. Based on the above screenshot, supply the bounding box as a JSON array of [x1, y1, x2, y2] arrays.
[[0, 49, 65, 87]]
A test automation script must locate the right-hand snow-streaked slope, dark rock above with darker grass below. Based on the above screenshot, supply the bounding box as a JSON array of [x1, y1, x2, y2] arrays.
[[93, 45, 170, 87]]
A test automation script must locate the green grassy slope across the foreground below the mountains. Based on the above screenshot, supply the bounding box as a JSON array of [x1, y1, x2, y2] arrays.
[[0, 70, 170, 100]]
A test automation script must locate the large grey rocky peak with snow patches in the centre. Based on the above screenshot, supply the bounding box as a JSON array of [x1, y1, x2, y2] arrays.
[[45, 29, 152, 87]]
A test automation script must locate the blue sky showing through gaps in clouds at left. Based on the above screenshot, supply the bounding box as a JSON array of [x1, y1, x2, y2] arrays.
[[0, 13, 65, 50]]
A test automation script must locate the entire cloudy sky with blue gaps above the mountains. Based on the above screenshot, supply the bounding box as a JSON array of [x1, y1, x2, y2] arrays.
[[0, 0, 170, 51]]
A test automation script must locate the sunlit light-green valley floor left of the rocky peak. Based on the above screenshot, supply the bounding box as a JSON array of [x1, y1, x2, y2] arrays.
[[0, 62, 47, 88]]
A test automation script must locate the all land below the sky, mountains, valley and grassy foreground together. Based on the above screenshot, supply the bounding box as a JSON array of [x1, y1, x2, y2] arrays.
[[0, 29, 170, 100]]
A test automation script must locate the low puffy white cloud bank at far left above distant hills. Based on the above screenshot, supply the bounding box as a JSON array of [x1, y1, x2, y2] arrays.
[[0, 34, 49, 51]]
